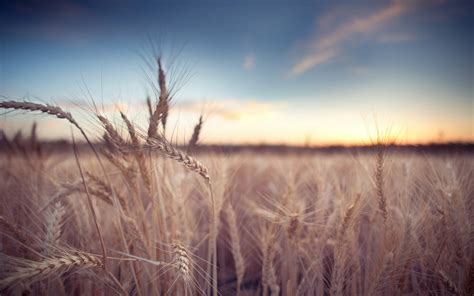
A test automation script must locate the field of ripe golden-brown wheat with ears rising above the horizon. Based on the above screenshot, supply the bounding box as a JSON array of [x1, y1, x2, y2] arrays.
[[0, 65, 474, 295]]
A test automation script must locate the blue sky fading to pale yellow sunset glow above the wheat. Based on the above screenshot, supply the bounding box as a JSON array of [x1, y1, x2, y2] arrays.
[[0, 0, 474, 145]]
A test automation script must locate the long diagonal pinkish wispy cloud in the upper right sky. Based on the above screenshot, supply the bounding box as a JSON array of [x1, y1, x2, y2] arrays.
[[290, 1, 410, 77]]
